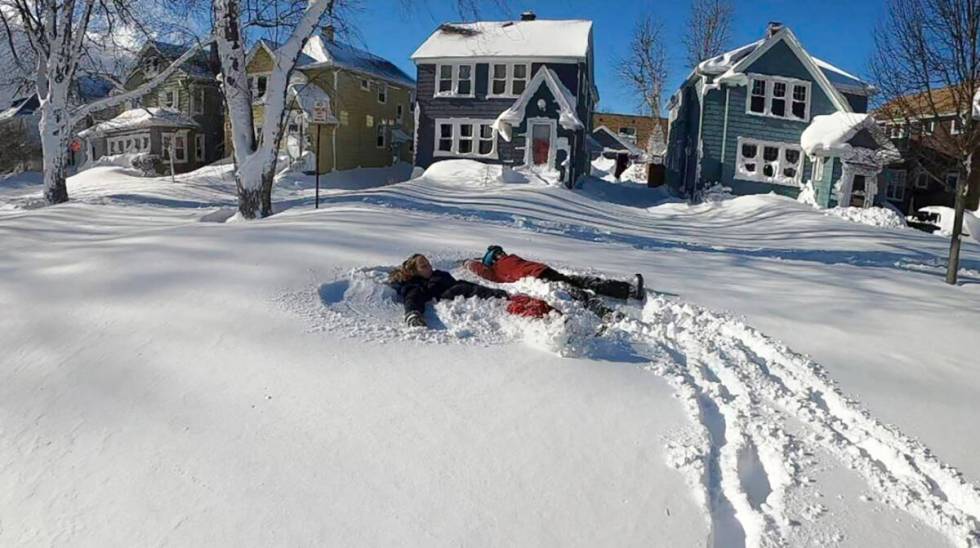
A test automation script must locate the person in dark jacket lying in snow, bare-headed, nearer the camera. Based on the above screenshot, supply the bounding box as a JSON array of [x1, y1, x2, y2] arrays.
[[388, 253, 554, 327]]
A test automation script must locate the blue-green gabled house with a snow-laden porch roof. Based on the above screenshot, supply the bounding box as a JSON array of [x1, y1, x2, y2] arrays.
[[666, 23, 896, 206]]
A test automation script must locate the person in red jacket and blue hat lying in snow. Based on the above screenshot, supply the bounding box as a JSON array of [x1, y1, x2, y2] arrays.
[[463, 245, 646, 317]]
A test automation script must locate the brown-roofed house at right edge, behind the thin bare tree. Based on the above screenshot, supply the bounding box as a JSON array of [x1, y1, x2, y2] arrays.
[[875, 87, 980, 214]]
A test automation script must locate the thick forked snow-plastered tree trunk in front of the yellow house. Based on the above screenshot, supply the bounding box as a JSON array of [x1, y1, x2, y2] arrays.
[[213, 0, 334, 219]]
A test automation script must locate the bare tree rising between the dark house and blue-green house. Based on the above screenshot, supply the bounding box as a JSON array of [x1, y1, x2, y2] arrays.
[[617, 15, 667, 154]]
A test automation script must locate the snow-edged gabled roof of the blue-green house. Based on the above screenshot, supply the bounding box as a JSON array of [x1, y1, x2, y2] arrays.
[[695, 26, 874, 103]]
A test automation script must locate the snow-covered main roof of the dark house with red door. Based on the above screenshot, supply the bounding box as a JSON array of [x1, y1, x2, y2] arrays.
[[412, 19, 592, 62]]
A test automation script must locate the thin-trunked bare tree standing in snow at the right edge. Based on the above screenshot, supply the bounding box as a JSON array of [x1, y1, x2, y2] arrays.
[[871, 0, 980, 284]]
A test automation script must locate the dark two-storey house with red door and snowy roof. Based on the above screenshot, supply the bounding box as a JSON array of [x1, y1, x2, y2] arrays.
[[412, 12, 599, 186]]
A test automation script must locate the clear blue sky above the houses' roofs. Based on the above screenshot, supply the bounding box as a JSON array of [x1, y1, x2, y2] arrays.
[[353, 0, 885, 112]]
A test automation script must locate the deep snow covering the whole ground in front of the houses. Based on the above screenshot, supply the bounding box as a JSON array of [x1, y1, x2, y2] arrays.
[[0, 164, 980, 546]]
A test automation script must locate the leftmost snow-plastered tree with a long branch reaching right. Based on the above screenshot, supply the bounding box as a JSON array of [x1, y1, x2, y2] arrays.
[[0, 0, 206, 204]]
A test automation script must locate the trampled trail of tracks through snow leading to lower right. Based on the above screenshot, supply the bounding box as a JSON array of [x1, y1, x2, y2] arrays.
[[619, 297, 980, 548]]
